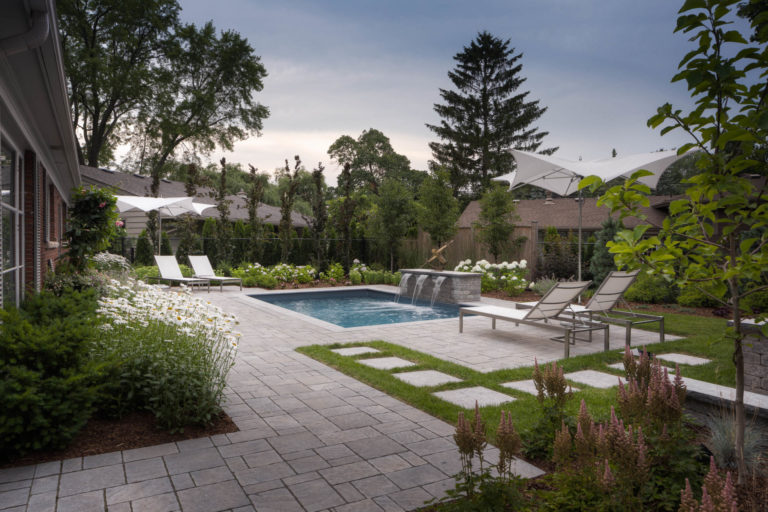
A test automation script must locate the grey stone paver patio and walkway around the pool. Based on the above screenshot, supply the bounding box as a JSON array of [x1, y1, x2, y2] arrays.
[[0, 286, 672, 512]]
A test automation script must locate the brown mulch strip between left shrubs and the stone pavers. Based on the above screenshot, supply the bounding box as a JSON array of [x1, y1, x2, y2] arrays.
[[0, 412, 239, 468]]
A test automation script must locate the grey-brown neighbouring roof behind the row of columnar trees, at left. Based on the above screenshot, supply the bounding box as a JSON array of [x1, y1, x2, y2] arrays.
[[80, 165, 307, 228]]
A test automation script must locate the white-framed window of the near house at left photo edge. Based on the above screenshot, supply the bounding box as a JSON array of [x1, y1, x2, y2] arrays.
[[0, 144, 24, 305]]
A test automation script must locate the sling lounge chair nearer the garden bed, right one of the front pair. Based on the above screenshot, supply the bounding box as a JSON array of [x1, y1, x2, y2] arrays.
[[517, 270, 664, 345]]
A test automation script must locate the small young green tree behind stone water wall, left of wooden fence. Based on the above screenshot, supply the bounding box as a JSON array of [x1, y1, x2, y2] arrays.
[[416, 169, 459, 247]]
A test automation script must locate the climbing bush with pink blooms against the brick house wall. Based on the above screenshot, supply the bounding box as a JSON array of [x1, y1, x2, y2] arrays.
[[65, 187, 118, 270]]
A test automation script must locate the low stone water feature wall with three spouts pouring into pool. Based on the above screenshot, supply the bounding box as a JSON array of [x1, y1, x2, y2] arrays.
[[400, 268, 481, 304]]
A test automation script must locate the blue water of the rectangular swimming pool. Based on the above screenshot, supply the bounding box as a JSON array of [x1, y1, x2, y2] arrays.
[[250, 290, 460, 327]]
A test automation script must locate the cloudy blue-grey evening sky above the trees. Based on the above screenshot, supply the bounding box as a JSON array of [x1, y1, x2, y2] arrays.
[[180, 0, 744, 184]]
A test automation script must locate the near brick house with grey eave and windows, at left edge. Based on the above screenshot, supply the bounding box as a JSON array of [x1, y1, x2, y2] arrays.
[[0, 0, 80, 304]]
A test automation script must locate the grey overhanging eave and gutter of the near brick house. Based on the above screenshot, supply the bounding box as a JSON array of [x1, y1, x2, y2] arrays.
[[0, 0, 80, 201]]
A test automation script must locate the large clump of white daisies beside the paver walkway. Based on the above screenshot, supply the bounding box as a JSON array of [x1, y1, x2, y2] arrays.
[[91, 279, 239, 430]]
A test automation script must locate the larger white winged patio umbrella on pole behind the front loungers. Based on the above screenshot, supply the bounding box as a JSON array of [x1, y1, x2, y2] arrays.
[[493, 149, 696, 281]]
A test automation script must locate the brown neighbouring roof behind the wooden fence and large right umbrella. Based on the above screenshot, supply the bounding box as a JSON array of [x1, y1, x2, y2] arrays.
[[457, 196, 671, 231]]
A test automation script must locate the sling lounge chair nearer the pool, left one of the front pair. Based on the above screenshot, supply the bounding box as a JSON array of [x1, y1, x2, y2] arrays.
[[459, 281, 609, 357]]
